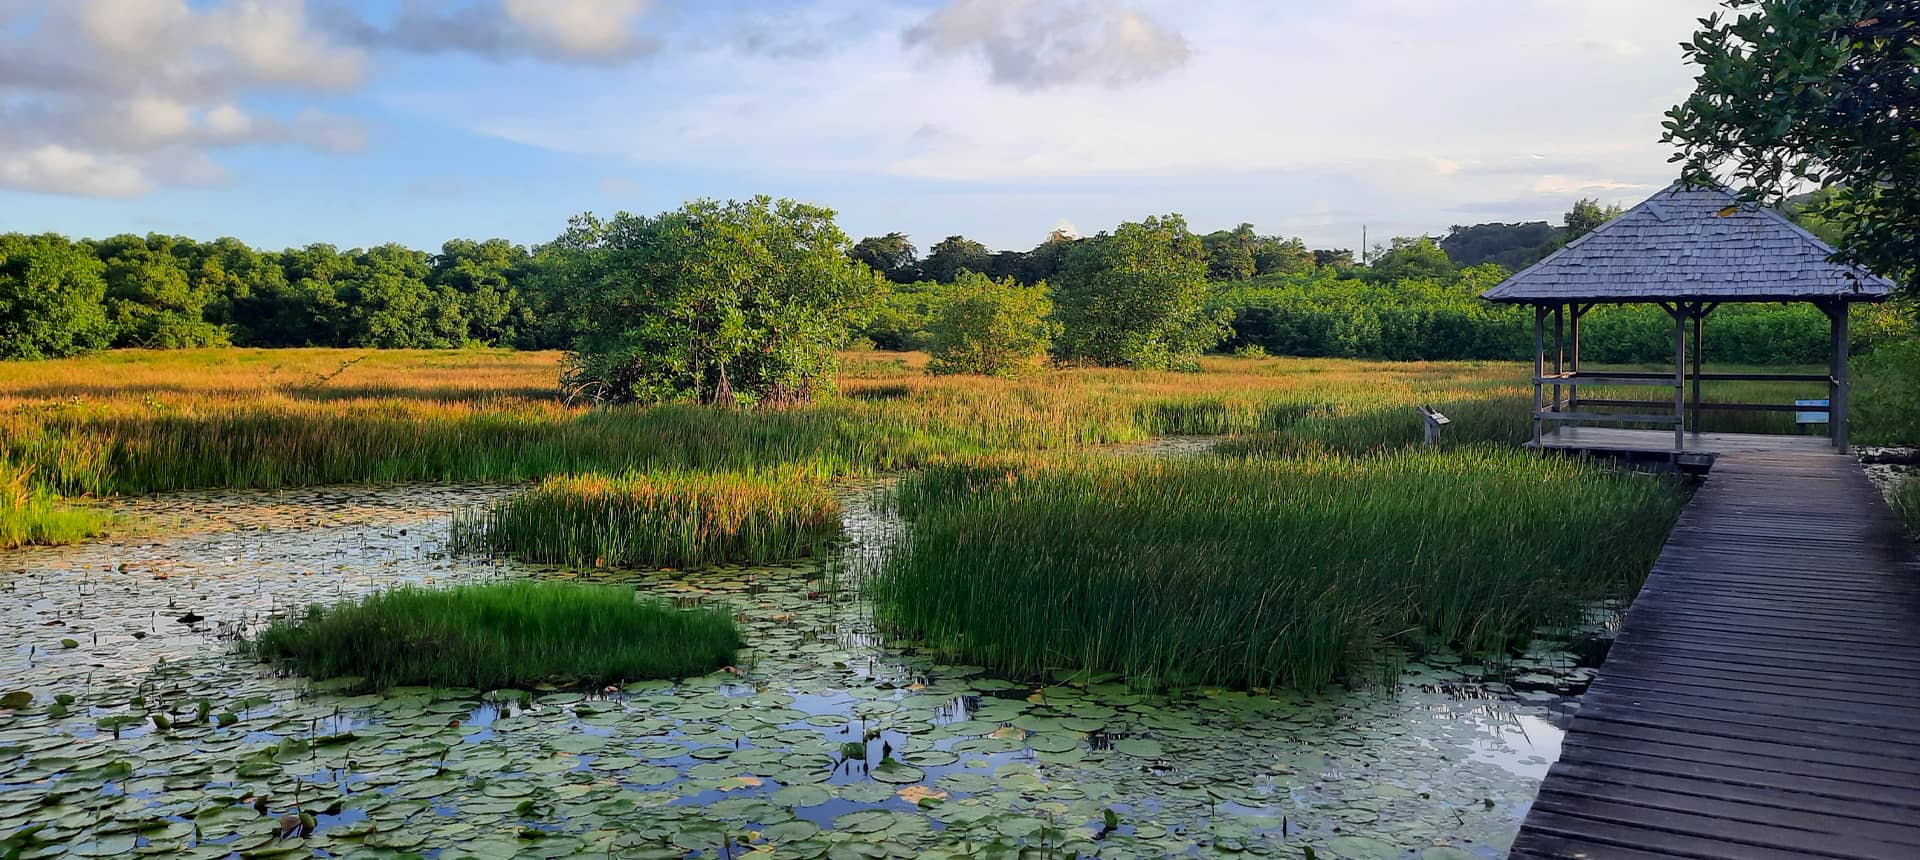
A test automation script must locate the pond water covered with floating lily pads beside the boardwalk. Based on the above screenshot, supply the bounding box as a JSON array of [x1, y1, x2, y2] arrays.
[[0, 470, 1609, 858]]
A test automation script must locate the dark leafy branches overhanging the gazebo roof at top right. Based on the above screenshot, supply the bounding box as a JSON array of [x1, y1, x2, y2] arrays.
[[1667, 0, 1920, 290]]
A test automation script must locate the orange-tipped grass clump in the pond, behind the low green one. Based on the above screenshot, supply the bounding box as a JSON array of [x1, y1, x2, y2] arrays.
[[453, 470, 841, 568]]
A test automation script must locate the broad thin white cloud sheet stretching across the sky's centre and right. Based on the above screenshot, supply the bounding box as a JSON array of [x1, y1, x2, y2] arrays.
[[439, 0, 1715, 244]]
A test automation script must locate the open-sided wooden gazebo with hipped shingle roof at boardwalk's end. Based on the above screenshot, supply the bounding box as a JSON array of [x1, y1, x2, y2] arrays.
[[1482, 184, 1893, 461]]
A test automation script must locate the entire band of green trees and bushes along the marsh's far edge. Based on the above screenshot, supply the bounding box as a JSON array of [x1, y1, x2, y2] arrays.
[[0, 198, 1908, 403]]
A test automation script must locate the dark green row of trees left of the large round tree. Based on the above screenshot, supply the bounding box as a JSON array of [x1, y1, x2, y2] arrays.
[[0, 234, 563, 359]]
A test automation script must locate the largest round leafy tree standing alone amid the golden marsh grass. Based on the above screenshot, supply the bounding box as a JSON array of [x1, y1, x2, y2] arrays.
[[549, 196, 887, 405]]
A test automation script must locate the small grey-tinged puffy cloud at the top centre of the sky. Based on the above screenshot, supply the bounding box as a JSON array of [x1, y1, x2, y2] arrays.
[[904, 0, 1192, 90]]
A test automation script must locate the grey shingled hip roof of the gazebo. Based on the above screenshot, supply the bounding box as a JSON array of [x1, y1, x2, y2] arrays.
[[1480, 184, 1893, 303]]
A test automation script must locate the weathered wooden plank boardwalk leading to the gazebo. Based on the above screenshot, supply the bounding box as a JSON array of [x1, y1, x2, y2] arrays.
[[1513, 451, 1920, 860]]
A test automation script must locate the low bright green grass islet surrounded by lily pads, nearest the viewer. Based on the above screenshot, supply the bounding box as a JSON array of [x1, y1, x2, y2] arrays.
[[252, 582, 741, 689]]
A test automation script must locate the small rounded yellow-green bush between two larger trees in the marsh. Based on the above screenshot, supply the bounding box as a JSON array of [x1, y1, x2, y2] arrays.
[[927, 273, 1060, 376]]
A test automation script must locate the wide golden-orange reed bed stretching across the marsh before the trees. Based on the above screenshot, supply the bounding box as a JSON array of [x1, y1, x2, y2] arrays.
[[0, 349, 1896, 541]]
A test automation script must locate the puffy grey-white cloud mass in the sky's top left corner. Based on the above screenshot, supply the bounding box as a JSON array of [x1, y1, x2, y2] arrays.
[[0, 0, 367, 196]]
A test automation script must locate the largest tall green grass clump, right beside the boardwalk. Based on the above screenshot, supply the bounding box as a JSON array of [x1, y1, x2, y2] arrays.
[[866, 449, 1682, 687]]
